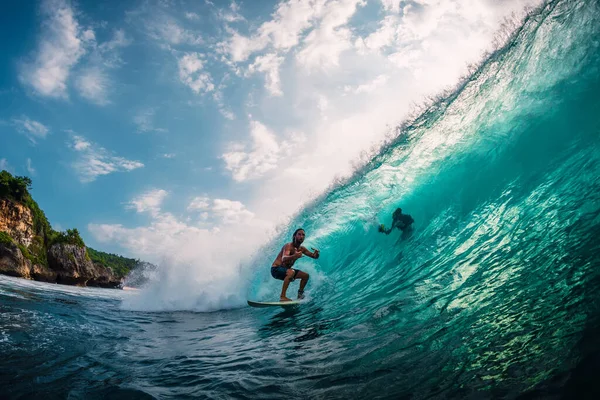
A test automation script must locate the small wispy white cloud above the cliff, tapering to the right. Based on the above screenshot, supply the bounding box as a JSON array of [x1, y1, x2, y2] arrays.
[[71, 135, 144, 182]]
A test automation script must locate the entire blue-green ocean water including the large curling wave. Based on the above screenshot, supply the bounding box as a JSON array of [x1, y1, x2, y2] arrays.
[[0, 0, 600, 399]]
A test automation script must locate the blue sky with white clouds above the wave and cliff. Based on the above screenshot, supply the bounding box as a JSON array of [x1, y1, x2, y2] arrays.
[[0, 0, 537, 265]]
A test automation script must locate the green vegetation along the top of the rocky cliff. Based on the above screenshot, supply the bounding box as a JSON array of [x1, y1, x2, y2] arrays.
[[0, 171, 140, 278]]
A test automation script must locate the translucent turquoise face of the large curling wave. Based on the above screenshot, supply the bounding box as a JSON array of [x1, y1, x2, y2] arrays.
[[252, 1, 600, 398]]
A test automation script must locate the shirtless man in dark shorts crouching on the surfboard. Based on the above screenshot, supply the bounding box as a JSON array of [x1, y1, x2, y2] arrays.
[[271, 228, 319, 301]]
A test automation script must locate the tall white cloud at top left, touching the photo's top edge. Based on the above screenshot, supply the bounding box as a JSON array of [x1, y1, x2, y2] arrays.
[[19, 0, 86, 98]]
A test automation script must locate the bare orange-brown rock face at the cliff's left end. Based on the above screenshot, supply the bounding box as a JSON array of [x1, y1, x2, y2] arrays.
[[0, 199, 35, 247]]
